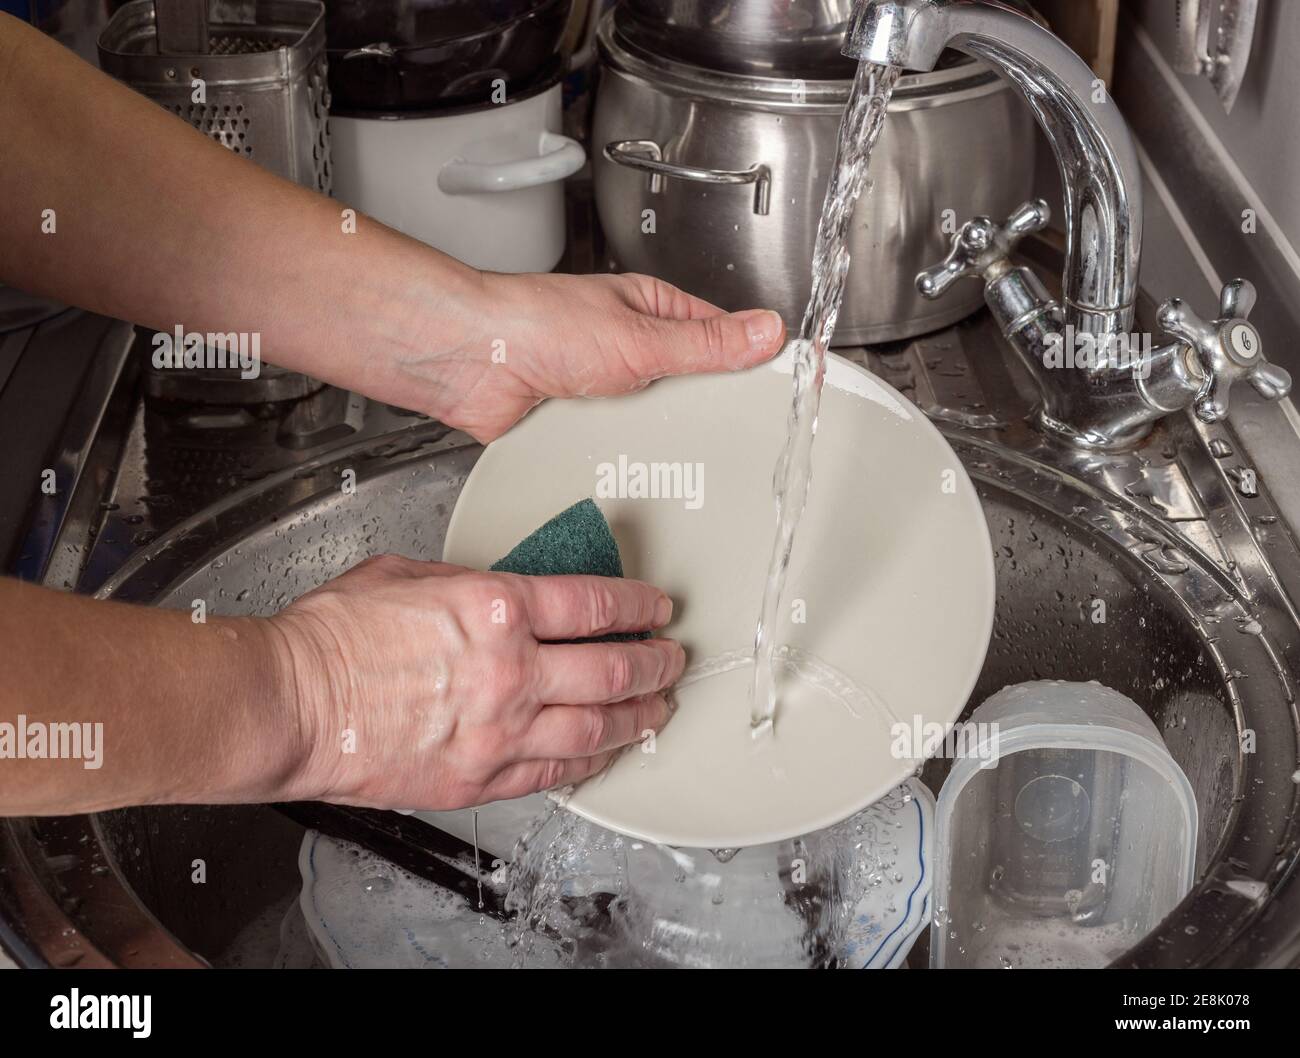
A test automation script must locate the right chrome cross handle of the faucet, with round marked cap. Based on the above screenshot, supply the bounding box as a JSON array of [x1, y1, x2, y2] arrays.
[[1156, 279, 1291, 422]]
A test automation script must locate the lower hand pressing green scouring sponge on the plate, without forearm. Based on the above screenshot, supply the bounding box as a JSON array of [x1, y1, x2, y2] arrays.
[[270, 555, 683, 810]]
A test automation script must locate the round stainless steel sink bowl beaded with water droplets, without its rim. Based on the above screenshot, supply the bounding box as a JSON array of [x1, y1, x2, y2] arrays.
[[83, 400, 1289, 964]]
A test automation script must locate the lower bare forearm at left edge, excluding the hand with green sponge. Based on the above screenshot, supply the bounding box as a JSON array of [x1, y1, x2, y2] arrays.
[[0, 577, 297, 816]]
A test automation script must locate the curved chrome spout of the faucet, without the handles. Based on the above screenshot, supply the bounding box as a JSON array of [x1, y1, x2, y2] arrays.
[[844, 0, 1141, 335]]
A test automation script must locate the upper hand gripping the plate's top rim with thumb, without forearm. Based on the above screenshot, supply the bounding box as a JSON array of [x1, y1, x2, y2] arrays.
[[400, 273, 785, 442]]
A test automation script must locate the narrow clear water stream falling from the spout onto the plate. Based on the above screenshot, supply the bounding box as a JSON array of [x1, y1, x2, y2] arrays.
[[750, 62, 900, 737]]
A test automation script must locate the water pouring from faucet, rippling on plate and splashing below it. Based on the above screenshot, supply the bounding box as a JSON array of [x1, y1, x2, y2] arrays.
[[475, 55, 910, 966]]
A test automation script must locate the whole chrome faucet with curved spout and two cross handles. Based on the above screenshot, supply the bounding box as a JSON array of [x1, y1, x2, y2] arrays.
[[844, 0, 1291, 447]]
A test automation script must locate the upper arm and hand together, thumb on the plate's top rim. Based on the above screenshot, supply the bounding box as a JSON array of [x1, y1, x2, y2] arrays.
[[0, 14, 784, 441]]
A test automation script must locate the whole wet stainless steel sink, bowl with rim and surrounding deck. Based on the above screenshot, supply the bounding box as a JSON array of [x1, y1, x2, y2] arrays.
[[7, 246, 1300, 966]]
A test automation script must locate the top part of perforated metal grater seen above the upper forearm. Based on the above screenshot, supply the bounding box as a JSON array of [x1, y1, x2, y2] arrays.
[[99, 0, 332, 195]]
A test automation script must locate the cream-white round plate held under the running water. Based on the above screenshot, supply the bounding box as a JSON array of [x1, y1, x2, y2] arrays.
[[443, 355, 995, 849]]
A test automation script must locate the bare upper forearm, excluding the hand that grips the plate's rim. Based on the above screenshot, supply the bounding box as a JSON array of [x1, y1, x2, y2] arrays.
[[0, 14, 481, 409]]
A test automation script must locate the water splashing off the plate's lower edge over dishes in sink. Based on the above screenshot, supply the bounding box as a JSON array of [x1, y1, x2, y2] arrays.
[[502, 786, 914, 968]]
